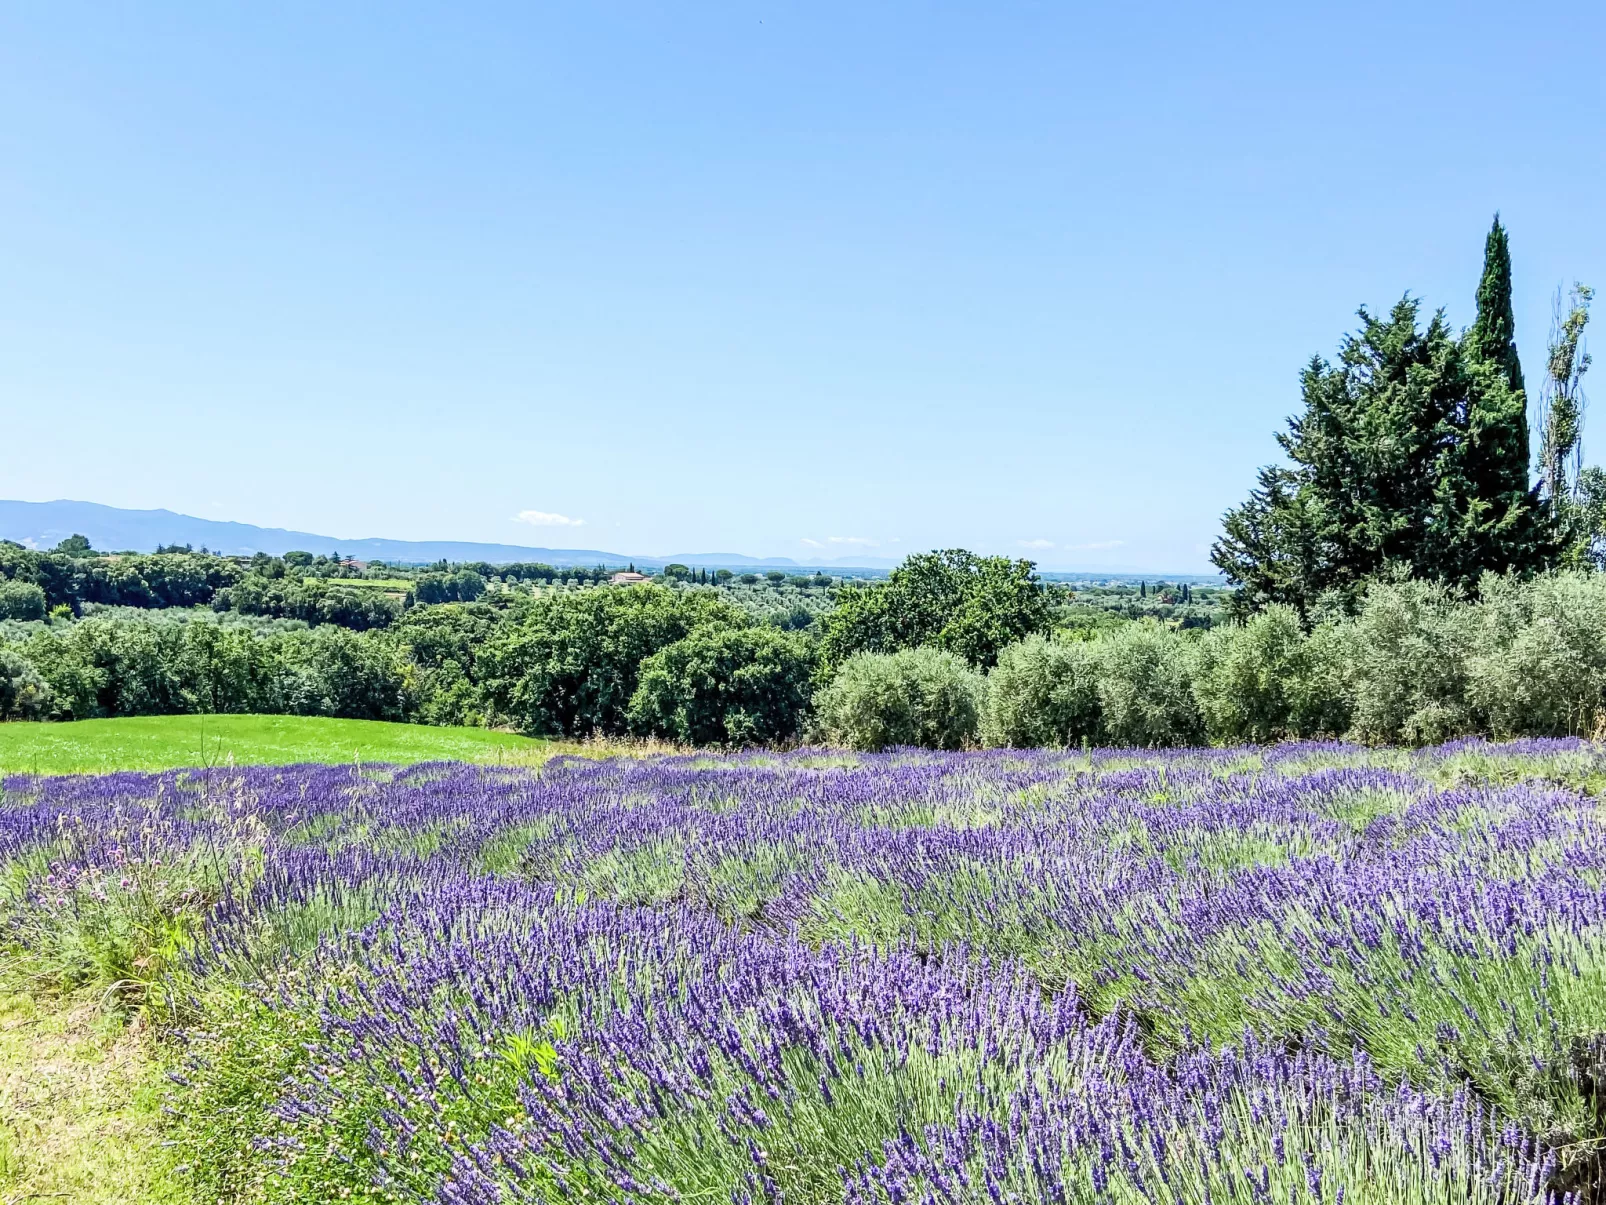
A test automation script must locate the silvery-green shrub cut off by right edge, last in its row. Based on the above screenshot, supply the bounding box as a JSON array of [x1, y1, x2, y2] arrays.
[[1466, 572, 1606, 736]]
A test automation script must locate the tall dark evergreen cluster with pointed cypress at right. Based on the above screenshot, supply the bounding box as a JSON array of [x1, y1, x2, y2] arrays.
[[1213, 219, 1558, 622]]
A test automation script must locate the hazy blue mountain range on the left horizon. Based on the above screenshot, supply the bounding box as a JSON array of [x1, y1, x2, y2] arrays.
[[0, 500, 898, 569]]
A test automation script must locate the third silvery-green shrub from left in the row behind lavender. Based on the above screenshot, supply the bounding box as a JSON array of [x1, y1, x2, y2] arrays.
[[1094, 622, 1205, 749]]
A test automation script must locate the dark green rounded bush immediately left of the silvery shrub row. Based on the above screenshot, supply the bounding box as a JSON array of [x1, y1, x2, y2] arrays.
[[628, 627, 813, 745]]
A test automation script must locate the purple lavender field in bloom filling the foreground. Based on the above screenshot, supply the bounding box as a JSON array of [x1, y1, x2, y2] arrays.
[[0, 741, 1606, 1205]]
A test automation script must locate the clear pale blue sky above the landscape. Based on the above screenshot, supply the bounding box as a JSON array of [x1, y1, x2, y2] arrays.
[[0, 0, 1606, 570]]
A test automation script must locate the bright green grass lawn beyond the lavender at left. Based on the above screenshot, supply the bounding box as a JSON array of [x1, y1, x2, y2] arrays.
[[0, 715, 556, 774]]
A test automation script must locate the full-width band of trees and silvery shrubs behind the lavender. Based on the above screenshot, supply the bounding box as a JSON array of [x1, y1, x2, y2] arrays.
[[9, 554, 1606, 747]]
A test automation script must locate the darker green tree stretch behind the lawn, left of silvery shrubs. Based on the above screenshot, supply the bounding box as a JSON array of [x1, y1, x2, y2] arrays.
[[0, 585, 814, 744]]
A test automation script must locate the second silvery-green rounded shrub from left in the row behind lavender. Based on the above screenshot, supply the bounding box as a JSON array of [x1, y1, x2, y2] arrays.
[[981, 635, 1103, 749]]
